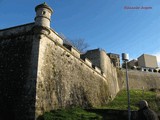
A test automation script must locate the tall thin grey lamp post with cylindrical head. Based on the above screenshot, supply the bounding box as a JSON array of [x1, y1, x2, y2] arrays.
[[122, 53, 131, 120]]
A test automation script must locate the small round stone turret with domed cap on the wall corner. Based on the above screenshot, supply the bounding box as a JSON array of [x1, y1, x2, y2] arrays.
[[35, 3, 53, 28]]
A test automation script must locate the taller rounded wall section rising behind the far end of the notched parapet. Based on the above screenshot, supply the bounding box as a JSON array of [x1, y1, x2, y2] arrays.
[[82, 49, 121, 98]]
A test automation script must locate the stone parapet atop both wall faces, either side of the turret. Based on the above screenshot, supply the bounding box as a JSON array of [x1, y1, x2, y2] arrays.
[[0, 22, 112, 78]]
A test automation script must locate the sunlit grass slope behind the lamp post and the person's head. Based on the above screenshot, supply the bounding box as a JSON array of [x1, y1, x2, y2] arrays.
[[102, 90, 160, 111]]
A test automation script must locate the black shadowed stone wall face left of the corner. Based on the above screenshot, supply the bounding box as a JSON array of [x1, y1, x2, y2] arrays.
[[0, 35, 35, 120]]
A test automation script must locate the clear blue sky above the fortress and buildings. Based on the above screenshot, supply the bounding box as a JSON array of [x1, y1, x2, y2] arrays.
[[0, 0, 160, 65]]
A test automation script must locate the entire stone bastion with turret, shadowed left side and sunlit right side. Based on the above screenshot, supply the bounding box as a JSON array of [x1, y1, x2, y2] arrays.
[[0, 4, 160, 120]]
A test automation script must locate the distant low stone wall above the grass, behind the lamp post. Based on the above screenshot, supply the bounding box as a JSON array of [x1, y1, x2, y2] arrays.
[[121, 70, 160, 90]]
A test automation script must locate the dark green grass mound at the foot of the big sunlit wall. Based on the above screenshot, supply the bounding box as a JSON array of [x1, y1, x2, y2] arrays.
[[37, 108, 102, 120]]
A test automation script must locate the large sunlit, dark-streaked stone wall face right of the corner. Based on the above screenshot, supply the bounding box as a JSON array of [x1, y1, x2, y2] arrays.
[[36, 36, 110, 115]]
